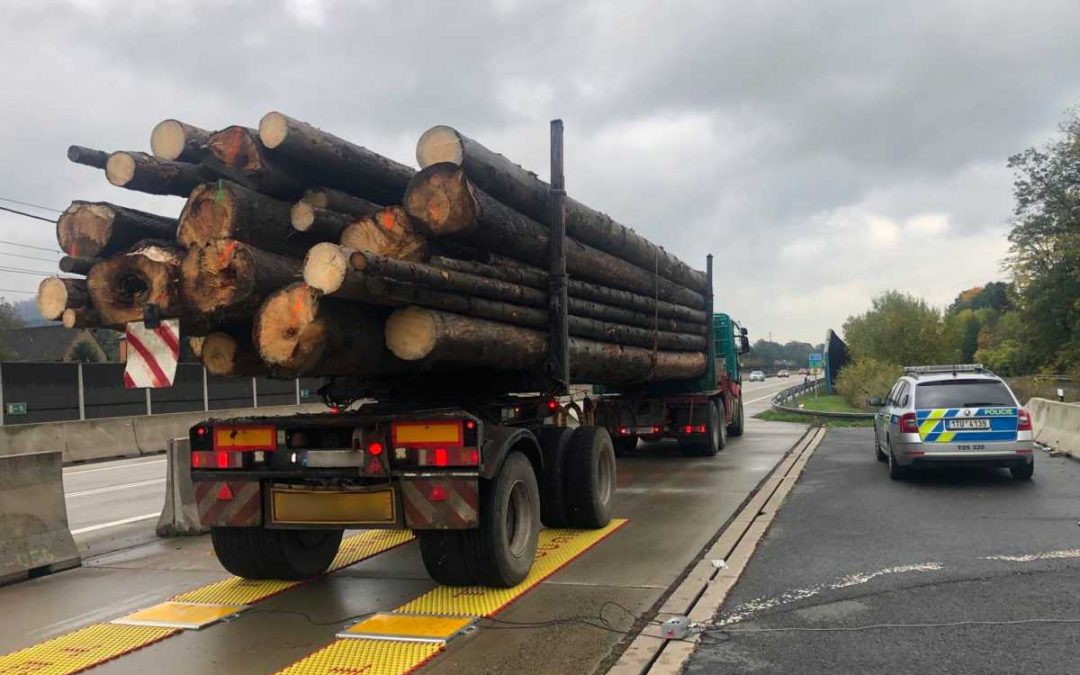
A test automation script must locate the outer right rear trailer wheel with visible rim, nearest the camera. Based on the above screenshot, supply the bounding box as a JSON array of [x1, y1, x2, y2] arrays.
[[462, 453, 540, 589]]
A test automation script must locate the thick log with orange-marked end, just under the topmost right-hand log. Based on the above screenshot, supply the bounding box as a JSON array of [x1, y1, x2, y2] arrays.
[[405, 163, 705, 309]]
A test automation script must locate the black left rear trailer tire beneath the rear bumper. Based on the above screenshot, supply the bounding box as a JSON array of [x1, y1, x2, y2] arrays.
[[210, 527, 345, 581]]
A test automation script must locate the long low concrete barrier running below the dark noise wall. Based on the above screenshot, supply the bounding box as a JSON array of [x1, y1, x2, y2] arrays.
[[0, 403, 326, 464]]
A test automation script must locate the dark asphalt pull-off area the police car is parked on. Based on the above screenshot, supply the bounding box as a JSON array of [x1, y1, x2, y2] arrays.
[[687, 429, 1080, 675]]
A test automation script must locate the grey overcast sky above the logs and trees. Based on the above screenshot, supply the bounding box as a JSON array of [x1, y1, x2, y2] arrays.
[[0, 0, 1080, 342]]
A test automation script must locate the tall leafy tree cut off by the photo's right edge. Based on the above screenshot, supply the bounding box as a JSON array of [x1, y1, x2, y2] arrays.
[[1007, 110, 1080, 369]]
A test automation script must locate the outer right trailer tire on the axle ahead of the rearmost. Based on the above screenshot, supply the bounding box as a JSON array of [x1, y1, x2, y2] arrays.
[[564, 427, 616, 529]]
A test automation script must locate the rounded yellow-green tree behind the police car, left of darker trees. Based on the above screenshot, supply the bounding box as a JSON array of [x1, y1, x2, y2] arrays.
[[843, 291, 958, 365]]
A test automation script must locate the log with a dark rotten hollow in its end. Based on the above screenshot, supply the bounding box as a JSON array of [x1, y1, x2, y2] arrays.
[[86, 242, 184, 325]]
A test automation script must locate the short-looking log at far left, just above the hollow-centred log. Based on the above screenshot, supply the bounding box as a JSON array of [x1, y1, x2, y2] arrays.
[[56, 201, 176, 257]]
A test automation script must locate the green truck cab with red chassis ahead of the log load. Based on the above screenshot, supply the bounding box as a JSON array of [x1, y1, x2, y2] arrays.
[[584, 313, 750, 456]]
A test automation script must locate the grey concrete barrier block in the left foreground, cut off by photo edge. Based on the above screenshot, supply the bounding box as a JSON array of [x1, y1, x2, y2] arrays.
[[0, 451, 82, 583]]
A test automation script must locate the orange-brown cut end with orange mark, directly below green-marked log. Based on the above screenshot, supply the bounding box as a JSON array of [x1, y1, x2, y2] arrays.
[[180, 239, 254, 313]]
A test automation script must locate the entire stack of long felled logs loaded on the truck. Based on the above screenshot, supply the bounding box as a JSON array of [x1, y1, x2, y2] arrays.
[[38, 112, 711, 384]]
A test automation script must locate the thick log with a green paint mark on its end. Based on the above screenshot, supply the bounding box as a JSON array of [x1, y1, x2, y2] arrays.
[[176, 180, 325, 258]]
